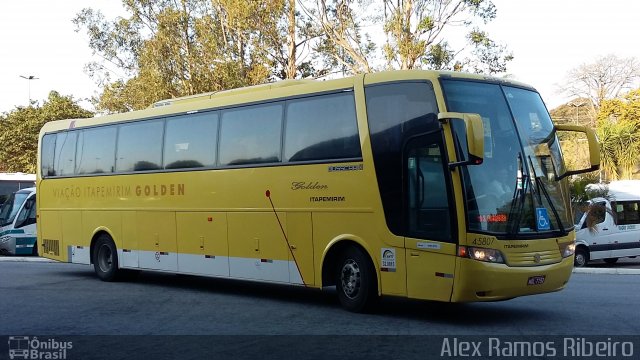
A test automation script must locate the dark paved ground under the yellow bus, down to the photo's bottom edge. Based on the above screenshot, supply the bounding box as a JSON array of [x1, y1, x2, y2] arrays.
[[0, 257, 640, 360]]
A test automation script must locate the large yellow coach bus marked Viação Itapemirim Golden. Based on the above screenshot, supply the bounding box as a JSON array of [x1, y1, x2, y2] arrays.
[[37, 71, 599, 311]]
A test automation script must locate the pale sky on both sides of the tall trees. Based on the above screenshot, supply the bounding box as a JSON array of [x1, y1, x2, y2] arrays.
[[0, 0, 640, 113]]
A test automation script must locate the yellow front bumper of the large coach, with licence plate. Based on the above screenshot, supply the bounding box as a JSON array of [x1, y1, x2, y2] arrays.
[[451, 256, 573, 302]]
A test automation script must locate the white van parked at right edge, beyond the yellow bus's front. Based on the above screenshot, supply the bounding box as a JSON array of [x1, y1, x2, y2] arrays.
[[575, 180, 640, 267]]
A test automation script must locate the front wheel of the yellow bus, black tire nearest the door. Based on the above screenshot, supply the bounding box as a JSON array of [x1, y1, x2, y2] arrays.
[[336, 246, 378, 312]]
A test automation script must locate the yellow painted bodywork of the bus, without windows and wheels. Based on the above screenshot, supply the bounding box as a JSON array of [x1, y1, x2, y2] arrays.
[[37, 71, 573, 301]]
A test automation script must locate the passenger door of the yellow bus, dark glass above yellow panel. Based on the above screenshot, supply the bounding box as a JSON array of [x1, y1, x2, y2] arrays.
[[403, 132, 456, 301]]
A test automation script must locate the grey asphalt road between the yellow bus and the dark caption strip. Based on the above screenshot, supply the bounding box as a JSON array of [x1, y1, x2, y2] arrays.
[[0, 261, 640, 336]]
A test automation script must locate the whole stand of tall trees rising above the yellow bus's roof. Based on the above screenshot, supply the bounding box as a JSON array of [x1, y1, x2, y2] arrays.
[[73, 0, 511, 112]]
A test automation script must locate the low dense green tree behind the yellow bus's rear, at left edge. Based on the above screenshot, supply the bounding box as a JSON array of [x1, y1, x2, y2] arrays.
[[0, 91, 93, 173]]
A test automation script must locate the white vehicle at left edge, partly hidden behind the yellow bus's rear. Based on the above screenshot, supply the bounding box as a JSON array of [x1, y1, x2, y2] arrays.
[[0, 187, 38, 255]]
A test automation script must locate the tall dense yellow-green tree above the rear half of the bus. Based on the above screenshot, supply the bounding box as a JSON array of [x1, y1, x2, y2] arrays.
[[74, 0, 285, 112]]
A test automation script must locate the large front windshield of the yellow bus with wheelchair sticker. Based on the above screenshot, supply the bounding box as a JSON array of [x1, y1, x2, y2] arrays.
[[442, 80, 573, 238]]
